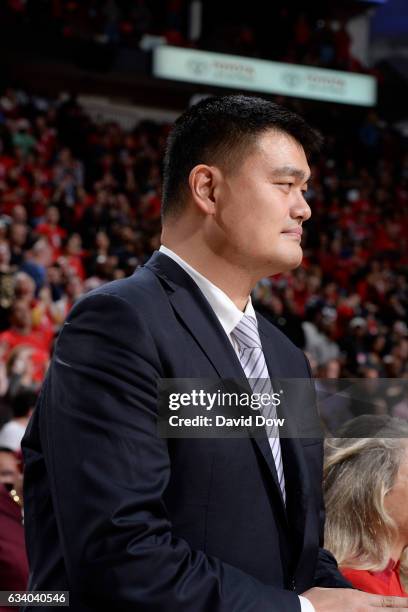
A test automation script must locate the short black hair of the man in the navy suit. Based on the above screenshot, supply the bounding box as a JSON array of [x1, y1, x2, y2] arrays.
[[162, 95, 322, 219]]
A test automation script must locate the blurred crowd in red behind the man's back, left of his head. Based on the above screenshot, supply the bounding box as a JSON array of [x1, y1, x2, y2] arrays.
[[0, 90, 168, 428]]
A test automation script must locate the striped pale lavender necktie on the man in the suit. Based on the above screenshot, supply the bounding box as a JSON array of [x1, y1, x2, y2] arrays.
[[231, 315, 286, 502]]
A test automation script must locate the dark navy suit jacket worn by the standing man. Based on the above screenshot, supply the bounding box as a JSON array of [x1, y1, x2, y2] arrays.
[[23, 252, 348, 612]]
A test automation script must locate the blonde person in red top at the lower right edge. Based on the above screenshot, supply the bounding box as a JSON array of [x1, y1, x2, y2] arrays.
[[323, 415, 408, 596]]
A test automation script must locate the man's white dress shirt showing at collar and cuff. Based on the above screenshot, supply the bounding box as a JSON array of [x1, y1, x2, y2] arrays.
[[159, 245, 316, 612]]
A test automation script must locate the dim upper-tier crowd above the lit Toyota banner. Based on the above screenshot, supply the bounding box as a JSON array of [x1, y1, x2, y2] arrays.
[[0, 0, 365, 71]]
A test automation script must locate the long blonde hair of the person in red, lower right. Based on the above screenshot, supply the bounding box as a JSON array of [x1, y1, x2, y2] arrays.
[[323, 417, 408, 575]]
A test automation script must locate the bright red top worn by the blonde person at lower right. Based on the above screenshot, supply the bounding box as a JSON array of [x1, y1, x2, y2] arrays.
[[341, 559, 408, 597]]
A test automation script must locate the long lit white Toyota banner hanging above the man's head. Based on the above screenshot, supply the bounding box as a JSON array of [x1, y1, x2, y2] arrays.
[[153, 46, 377, 106]]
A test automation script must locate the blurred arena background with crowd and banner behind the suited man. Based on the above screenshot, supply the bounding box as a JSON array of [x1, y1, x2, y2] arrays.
[[0, 0, 408, 604]]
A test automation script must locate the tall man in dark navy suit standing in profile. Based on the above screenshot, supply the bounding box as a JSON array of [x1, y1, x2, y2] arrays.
[[23, 96, 408, 612]]
